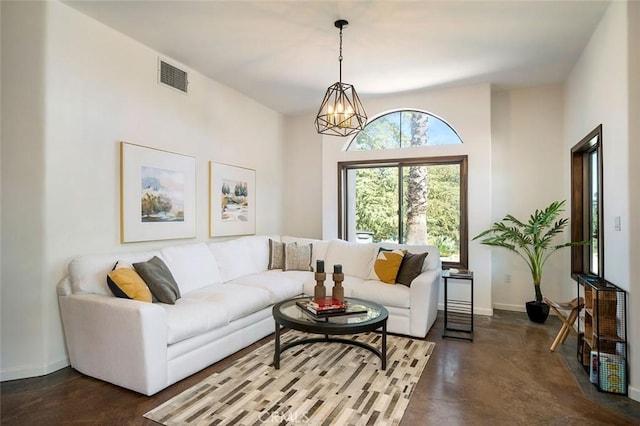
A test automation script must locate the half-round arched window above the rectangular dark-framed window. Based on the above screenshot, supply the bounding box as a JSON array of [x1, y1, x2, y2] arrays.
[[347, 110, 462, 151]]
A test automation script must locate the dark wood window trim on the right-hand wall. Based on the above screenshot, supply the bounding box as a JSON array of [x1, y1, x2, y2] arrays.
[[571, 125, 604, 278]]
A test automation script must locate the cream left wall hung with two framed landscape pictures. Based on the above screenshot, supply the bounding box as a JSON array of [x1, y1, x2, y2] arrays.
[[1, 2, 284, 380]]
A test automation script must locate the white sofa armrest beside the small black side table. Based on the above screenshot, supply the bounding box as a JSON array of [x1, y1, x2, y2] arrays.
[[409, 269, 442, 337]]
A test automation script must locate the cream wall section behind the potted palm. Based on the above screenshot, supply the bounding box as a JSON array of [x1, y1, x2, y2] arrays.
[[491, 86, 576, 311]]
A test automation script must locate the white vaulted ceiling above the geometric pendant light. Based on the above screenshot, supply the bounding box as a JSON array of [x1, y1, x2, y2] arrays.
[[65, 0, 609, 114]]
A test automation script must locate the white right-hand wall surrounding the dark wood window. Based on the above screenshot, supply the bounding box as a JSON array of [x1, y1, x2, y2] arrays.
[[565, 2, 640, 400]]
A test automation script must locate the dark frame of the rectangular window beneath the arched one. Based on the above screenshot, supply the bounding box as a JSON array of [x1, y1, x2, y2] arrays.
[[338, 155, 469, 269]]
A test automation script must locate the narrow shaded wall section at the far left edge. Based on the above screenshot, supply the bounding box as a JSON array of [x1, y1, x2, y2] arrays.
[[0, 2, 50, 380]]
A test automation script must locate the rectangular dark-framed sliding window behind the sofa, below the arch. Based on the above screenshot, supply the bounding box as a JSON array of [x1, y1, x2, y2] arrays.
[[340, 157, 467, 267]]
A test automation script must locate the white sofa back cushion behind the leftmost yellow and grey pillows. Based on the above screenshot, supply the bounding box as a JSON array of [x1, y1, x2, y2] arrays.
[[69, 251, 160, 296]]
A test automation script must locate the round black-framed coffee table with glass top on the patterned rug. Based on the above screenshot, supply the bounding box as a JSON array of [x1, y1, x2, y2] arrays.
[[273, 297, 389, 370]]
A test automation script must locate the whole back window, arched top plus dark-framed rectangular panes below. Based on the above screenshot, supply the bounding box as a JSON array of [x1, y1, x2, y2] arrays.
[[338, 110, 468, 268]]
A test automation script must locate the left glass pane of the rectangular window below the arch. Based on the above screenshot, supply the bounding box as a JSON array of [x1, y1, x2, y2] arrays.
[[348, 167, 398, 242]]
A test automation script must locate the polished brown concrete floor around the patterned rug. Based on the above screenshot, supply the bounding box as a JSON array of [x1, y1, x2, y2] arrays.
[[0, 311, 640, 426]]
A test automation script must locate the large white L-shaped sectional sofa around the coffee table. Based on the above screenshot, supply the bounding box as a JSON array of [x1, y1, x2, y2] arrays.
[[58, 236, 441, 395]]
